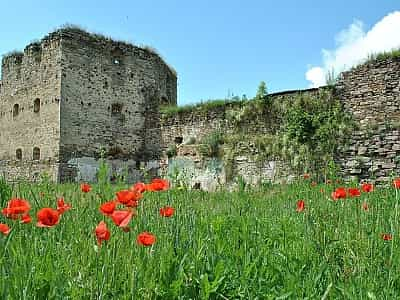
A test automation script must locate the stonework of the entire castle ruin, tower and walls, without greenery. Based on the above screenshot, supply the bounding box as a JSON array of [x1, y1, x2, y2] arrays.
[[0, 28, 400, 189]]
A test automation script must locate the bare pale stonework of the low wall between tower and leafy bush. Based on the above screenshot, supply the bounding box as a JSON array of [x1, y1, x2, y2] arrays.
[[160, 88, 326, 190]]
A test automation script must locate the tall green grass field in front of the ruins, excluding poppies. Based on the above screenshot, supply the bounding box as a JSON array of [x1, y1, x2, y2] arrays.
[[0, 181, 400, 299]]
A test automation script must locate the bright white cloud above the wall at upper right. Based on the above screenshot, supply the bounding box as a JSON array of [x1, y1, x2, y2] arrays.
[[305, 11, 400, 87]]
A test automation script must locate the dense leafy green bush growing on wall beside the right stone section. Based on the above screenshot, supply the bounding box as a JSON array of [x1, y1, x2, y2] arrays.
[[277, 91, 353, 176]]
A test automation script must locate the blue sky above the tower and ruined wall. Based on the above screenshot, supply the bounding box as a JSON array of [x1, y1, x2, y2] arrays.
[[0, 0, 400, 104]]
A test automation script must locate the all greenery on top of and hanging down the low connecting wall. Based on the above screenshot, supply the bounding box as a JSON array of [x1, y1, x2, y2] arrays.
[[163, 82, 354, 180]]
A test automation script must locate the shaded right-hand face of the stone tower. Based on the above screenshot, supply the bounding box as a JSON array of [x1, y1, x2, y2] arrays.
[[60, 30, 176, 180]]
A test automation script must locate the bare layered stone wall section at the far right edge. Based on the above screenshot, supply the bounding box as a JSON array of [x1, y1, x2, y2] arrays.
[[336, 58, 400, 181]]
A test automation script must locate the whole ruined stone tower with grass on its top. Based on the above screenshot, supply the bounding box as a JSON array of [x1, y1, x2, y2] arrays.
[[0, 28, 177, 182]]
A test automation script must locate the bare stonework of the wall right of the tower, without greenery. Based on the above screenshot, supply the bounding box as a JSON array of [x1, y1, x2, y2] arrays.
[[157, 58, 400, 189]]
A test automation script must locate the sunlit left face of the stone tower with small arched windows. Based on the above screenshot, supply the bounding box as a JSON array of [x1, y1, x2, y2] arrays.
[[0, 39, 61, 179]]
